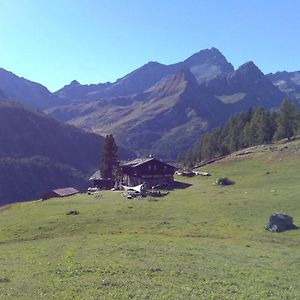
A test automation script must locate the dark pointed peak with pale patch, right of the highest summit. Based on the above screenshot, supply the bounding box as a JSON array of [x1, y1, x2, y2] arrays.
[[203, 61, 284, 111]]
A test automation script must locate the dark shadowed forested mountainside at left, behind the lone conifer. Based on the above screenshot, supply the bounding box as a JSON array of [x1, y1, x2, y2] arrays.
[[0, 99, 128, 205]]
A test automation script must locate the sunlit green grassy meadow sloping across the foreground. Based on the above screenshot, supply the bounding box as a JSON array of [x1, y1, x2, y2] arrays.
[[0, 142, 300, 299]]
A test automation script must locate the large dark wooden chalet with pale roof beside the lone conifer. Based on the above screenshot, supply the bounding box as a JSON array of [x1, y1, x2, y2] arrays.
[[116, 157, 176, 188]]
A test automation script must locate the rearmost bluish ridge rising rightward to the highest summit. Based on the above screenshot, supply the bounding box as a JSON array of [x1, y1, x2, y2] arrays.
[[54, 48, 233, 104]]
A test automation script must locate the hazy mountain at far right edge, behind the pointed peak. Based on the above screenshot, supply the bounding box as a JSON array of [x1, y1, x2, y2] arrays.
[[267, 71, 300, 105]]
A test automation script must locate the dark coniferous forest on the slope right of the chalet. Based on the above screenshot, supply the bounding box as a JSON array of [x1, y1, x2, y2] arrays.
[[178, 100, 300, 167]]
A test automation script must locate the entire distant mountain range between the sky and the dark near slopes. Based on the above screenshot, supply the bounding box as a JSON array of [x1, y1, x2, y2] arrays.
[[0, 48, 300, 159]]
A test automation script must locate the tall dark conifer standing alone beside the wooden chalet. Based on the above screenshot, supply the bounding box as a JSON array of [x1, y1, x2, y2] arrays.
[[100, 134, 118, 178]]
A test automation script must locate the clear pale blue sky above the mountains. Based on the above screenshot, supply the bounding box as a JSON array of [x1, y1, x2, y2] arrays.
[[0, 0, 300, 91]]
